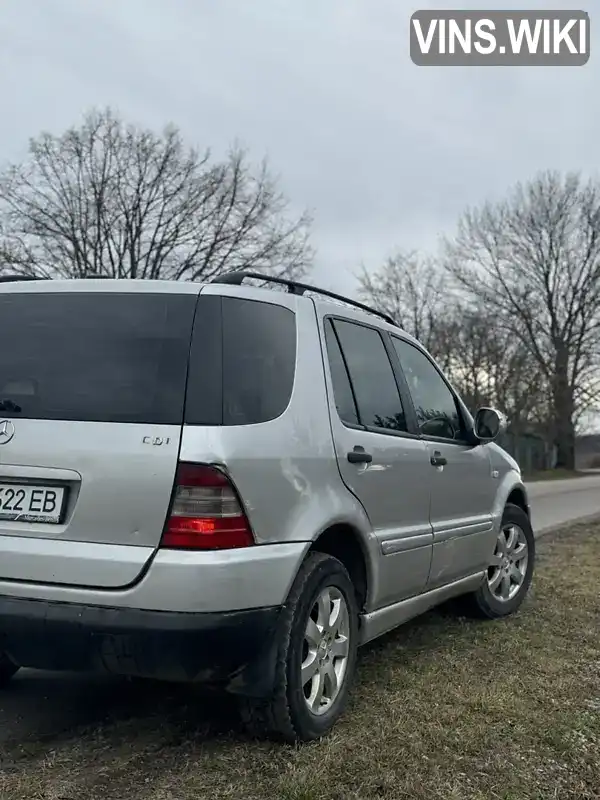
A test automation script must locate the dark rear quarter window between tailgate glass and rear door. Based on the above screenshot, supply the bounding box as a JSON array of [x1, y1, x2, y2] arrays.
[[185, 295, 296, 425]]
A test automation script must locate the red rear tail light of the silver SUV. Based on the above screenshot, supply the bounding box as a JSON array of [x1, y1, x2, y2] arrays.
[[161, 464, 254, 550]]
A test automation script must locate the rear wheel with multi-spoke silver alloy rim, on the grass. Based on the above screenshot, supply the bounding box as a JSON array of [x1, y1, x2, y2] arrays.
[[241, 552, 358, 744]]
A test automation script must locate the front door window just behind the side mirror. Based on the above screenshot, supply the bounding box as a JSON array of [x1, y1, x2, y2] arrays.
[[392, 337, 462, 439]]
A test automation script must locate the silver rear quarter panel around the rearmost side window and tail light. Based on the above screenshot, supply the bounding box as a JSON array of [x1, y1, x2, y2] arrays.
[[180, 285, 378, 608]]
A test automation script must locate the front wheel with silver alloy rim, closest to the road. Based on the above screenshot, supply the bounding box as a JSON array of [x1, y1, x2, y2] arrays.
[[461, 503, 535, 619]]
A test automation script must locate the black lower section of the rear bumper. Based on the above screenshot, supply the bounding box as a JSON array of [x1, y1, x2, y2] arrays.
[[0, 596, 280, 694]]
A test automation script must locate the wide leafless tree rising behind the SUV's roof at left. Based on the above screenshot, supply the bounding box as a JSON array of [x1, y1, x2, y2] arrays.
[[0, 110, 312, 280]]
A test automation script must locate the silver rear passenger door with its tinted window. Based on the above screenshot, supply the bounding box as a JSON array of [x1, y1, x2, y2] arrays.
[[323, 317, 433, 608]]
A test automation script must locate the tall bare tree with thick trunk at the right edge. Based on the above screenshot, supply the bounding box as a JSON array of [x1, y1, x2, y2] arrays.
[[447, 173, 600, 469]]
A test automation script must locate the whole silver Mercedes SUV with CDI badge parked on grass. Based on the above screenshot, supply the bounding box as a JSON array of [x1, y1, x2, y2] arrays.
[[0, 273, 535, 741]]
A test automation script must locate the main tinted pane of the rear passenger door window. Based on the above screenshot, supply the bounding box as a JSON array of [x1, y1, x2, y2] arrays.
[[335, 320, 407, 431]]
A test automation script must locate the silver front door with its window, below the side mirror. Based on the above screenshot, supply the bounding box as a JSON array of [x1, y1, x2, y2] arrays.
[[391, 336, 497, 589]]
